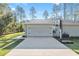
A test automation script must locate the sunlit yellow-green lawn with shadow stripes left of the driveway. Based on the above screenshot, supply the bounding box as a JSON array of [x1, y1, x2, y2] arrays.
[[0, 32, 24, 56]]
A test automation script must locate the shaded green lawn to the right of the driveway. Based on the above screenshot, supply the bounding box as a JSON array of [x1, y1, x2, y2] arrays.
[[66, 38, 79, 54]]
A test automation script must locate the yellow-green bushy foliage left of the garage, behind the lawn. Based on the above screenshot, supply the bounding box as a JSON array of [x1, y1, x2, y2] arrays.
[[4, 21, 23, 34]]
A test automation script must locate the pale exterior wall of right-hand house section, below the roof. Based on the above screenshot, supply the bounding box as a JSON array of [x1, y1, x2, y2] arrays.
[[63, 25, 79, 37]]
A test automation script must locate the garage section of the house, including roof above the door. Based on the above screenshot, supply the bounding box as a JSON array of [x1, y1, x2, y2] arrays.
[[24, 20, 53, 36]]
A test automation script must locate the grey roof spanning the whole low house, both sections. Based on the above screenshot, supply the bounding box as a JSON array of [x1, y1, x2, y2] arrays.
[[24, 19, 79, 25]]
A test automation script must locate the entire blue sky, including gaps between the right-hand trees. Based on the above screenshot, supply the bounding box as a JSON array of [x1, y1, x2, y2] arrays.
[[9, 3, 79, 20]]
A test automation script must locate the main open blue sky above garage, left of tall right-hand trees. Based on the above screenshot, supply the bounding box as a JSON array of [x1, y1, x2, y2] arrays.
[[9, 3, 58, 18]]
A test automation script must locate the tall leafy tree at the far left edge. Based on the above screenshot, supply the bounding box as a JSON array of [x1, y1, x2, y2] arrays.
[[0, 4, 12, 35]]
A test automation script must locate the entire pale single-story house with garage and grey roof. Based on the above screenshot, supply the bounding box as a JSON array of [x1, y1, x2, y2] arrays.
[[24, 19, 79, 37]]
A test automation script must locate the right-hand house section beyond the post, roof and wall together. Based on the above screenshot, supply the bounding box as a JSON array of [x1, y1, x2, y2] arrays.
[[63, 21, 79, 37]]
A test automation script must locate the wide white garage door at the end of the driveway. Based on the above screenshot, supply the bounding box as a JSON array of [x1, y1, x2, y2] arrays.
[[27, 25, 52, 36]]
